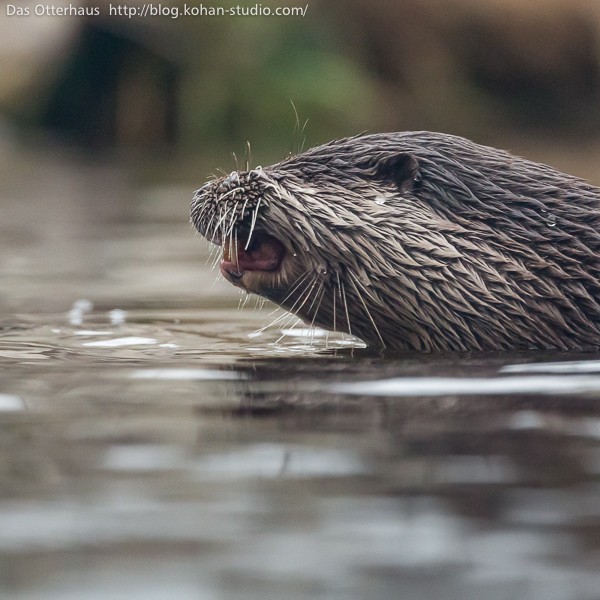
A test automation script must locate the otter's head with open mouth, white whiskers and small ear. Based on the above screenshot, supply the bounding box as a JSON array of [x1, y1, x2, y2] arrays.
[[191, 138, 419, 346]]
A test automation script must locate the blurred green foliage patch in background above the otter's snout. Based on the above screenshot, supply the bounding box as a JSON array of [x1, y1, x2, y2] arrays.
[[182, 18, 374, 161]]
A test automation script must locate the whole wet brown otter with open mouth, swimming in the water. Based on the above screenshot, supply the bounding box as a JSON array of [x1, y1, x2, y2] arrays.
[[191, 132, 600, 351]]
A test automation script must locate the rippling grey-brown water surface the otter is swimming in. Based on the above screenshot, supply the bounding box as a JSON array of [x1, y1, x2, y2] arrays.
[[0, 143, 600, 600]]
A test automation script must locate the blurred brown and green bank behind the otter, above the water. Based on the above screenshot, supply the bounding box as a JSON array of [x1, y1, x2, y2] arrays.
[[0, 0, 600, 175]]
